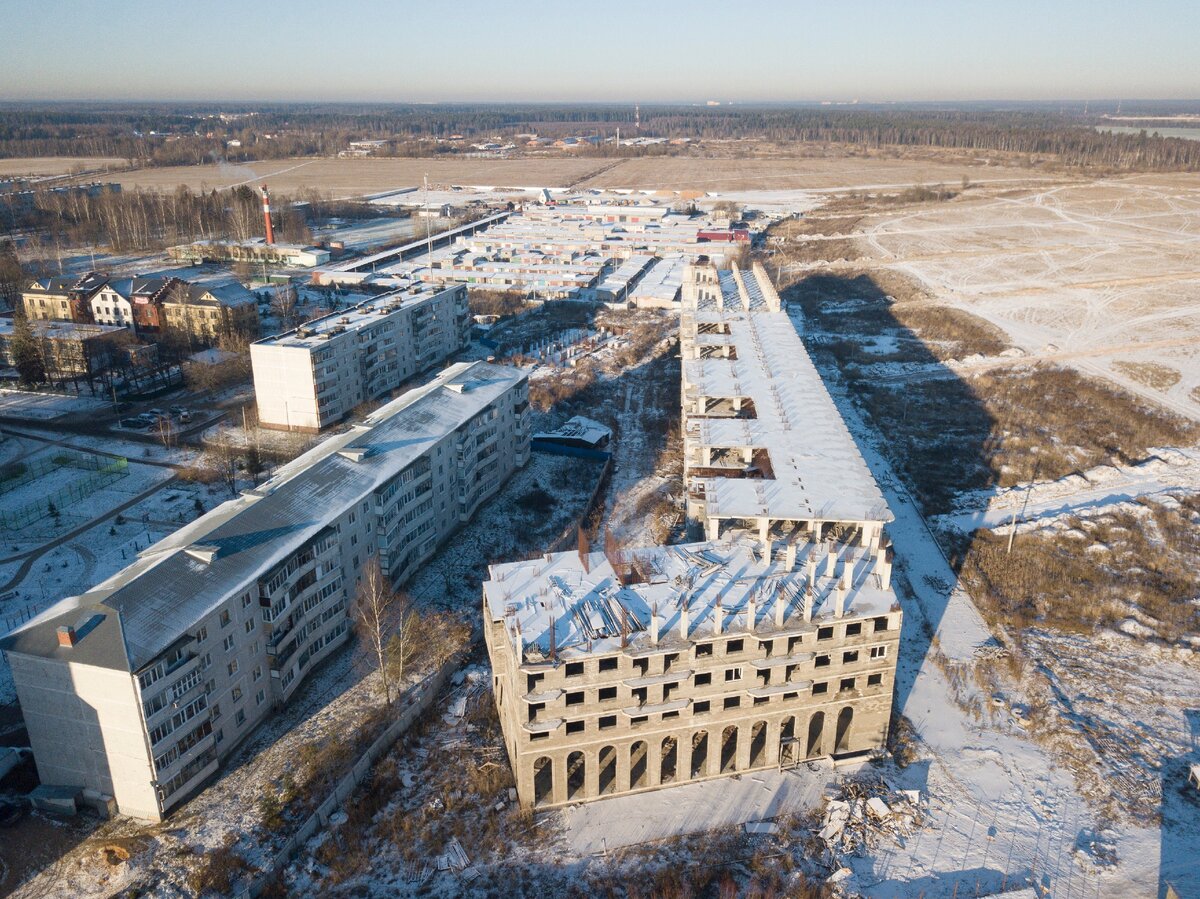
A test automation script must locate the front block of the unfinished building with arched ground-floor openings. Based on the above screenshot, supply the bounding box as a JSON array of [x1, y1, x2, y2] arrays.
[[484, 535, 901, 808]]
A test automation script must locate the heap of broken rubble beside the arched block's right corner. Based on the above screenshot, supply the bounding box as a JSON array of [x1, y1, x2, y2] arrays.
[[817, 778, 925, 869]]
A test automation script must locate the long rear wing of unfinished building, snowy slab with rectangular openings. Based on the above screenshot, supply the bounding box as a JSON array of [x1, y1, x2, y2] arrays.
[[679, 263, 892, 546]]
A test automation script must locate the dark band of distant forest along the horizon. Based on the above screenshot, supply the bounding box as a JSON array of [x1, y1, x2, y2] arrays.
[[0, 104, 1200, 170]]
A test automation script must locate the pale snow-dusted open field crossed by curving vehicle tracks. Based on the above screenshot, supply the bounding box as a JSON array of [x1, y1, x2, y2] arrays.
[[860, 174, 1200, 418]]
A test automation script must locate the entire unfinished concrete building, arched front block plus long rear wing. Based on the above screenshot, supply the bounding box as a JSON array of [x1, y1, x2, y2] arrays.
[[482, 263, 901, 807]]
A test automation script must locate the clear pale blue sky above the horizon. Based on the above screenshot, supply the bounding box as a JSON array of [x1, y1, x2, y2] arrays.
[[0, 0, 1200, 102]]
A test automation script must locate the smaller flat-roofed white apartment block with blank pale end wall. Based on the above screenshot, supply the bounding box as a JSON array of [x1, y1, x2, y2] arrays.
[[250, 287, 470, 432]]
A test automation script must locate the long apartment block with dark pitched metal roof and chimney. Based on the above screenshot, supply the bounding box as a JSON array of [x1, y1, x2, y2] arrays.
[[0, 362, 529, 820]]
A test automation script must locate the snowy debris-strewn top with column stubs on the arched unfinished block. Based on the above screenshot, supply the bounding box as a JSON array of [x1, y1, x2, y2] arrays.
[[484, 537, 895, 661]]
